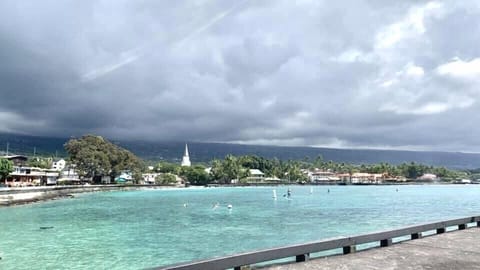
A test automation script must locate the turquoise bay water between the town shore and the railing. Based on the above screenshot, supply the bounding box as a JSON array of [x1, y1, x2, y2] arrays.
[[0, 185, 480, 269]]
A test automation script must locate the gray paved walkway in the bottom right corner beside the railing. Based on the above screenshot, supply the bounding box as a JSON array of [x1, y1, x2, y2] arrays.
[[267, 228, 480, 270]]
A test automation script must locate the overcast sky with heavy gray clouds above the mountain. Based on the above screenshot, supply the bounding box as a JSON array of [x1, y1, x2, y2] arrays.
[[0, 0, 480, 152]]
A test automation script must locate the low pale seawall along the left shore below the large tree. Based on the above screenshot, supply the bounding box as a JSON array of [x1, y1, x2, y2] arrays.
[[0, 185, 173, 207]]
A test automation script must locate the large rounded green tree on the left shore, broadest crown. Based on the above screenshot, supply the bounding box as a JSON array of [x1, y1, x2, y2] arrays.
[[64, 135, 143, 182]]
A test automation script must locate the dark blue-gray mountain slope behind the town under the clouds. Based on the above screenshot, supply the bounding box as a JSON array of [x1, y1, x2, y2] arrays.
[[0, 134, 480, 169]]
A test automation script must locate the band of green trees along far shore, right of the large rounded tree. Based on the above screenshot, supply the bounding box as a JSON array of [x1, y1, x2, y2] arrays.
[[151, 155, 469, 185]]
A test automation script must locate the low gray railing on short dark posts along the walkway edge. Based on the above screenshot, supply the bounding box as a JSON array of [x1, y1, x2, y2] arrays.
[[152, 216, 480, 270]]
